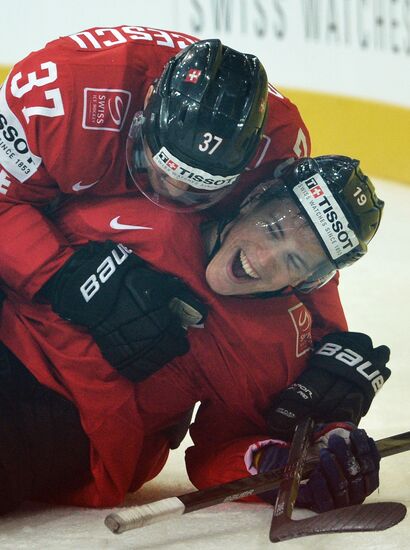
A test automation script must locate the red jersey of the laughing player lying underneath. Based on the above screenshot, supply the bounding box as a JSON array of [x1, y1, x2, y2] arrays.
[[0, 197, 346, 506]]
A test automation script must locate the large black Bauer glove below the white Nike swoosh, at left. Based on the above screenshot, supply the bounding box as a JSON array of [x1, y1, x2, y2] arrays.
[[42, 241, 206, 382]]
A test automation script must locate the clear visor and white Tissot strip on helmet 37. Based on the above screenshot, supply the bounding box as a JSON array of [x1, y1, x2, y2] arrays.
[[126, 112, 239, 212]]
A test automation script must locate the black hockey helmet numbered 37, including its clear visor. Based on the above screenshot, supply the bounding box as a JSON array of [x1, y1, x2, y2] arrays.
[[127, 39, 267, 209]]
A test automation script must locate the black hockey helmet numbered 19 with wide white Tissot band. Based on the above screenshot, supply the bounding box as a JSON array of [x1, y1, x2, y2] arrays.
[[283, 155, 384, 269]]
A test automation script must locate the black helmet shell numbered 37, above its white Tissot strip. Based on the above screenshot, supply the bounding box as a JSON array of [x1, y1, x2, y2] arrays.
[[143, 39, 267, 176]]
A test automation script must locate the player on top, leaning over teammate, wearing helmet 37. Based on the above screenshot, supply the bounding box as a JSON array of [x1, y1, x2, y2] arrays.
[[0, 26, 310, 382]]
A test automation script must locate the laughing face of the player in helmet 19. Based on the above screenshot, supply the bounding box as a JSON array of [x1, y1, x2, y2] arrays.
[[206, 198, 327, 295]]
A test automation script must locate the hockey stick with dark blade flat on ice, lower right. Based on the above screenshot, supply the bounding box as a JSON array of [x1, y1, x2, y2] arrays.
[[269, 419, 407, 542]]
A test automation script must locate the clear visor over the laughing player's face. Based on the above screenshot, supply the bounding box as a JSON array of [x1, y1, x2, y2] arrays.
[[227, 181, 336, 292]]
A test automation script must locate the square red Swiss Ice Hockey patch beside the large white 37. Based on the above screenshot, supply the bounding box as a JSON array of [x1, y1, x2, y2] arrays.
[[83, 88, 131, 132]]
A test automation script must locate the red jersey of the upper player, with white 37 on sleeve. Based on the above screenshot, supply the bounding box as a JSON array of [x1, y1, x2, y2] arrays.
[[0, 26, 310, 297]]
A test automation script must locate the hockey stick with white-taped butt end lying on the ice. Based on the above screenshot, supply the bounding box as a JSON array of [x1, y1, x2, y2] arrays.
[[105, 432, 410, 534]]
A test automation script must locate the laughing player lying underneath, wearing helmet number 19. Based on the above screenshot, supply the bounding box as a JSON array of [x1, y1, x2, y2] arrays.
[[0, 157, 389, 516]]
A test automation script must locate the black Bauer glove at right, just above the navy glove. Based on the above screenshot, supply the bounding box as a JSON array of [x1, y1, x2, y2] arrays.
[[267, 332, 390, 439]]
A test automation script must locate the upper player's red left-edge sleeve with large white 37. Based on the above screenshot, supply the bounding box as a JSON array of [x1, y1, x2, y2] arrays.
[[0, 50, 78, 298]]
